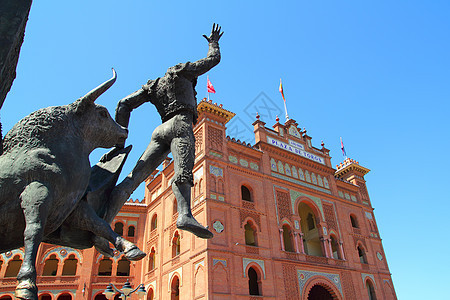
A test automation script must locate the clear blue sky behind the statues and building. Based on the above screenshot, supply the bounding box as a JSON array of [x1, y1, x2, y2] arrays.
[[0, 0, 450, 300]]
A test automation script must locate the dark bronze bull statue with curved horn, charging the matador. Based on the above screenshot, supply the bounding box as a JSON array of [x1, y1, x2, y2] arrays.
[[0, 69, 145, 300]]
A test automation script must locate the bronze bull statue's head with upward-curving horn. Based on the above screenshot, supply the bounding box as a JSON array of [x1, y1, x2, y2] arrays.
[[73, 69, 128, 150]]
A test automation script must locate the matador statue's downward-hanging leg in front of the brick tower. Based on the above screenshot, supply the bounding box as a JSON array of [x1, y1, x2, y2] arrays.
[[171, 126, 214, 239]]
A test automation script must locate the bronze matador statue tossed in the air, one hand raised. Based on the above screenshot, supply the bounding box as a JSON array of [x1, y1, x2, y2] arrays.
[[105, 24, 223, 238]]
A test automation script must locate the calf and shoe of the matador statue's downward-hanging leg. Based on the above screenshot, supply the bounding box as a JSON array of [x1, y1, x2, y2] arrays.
[[172, 182, 214, 239]]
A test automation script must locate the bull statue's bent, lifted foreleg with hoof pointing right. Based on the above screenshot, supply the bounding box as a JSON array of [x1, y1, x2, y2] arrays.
[[66, 201, 146, 260]]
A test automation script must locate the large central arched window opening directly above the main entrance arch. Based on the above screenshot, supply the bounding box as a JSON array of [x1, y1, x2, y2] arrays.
[[298, 202, 324, 256]]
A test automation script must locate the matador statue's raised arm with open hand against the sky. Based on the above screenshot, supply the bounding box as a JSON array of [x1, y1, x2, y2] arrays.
[[184, 24, 223, 77]]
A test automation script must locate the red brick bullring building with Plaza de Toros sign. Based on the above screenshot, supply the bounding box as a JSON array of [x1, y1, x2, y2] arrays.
[[0, 101, 396, 300]]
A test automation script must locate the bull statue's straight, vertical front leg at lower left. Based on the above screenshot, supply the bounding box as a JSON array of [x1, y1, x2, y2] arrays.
[[15, 182, 51, 300]]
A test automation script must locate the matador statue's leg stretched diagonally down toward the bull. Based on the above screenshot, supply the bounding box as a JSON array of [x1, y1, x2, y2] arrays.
[[104, 123, 170, 223]]
